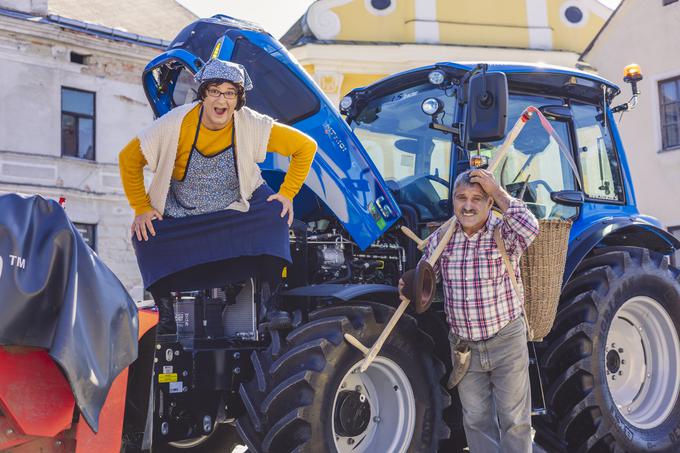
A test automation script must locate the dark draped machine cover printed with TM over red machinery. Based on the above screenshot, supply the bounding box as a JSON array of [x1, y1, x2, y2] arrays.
[[0, 194, 138, 432]]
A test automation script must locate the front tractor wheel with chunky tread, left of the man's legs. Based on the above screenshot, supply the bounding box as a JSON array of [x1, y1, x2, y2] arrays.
[[237, 303, 450, 453]]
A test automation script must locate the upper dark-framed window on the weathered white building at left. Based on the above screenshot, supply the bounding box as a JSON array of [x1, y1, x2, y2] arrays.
[[61, 87, 95, 160]]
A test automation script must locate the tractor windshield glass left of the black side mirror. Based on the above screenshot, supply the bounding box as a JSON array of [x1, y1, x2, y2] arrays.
[[351, 84, 456, 222]]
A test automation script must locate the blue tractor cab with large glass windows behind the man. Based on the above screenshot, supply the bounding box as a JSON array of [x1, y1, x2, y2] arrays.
[[341, 63, 636, 238]]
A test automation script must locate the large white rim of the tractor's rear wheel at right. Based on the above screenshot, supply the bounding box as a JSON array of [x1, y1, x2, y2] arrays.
[[604, 296, 680, 429]]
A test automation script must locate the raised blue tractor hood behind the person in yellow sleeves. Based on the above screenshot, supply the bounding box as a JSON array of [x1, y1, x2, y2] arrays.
[[143, 16, 401, 249]]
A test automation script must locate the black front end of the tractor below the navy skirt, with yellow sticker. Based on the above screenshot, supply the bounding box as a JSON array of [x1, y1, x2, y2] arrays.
[[153, 278, 260, 447]]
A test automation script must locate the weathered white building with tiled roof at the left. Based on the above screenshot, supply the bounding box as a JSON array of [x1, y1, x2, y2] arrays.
[[0, 0, 196, 298]]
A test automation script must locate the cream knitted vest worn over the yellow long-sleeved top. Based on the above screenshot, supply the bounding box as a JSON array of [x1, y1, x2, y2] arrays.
[[138, 102, 274, 214]]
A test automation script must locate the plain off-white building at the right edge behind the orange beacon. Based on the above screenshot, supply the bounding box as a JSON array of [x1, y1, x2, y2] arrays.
[[581, 0, 680, 263]]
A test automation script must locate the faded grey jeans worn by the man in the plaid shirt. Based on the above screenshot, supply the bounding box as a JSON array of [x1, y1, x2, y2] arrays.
[[451, 316, 531, 453]]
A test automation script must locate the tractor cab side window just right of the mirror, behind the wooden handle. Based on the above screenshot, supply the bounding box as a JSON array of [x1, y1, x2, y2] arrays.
[[471, 94, 577, 219]]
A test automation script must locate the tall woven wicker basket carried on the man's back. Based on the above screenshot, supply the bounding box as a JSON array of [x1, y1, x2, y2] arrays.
[[520, 220, 571, 341]]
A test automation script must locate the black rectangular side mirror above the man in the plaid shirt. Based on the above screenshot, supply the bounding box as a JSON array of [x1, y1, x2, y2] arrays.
[[465, 72, 508, 143]]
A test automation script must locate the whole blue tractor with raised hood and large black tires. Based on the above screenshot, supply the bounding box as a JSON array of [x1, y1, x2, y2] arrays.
[[134, 16, 680, 453]]
